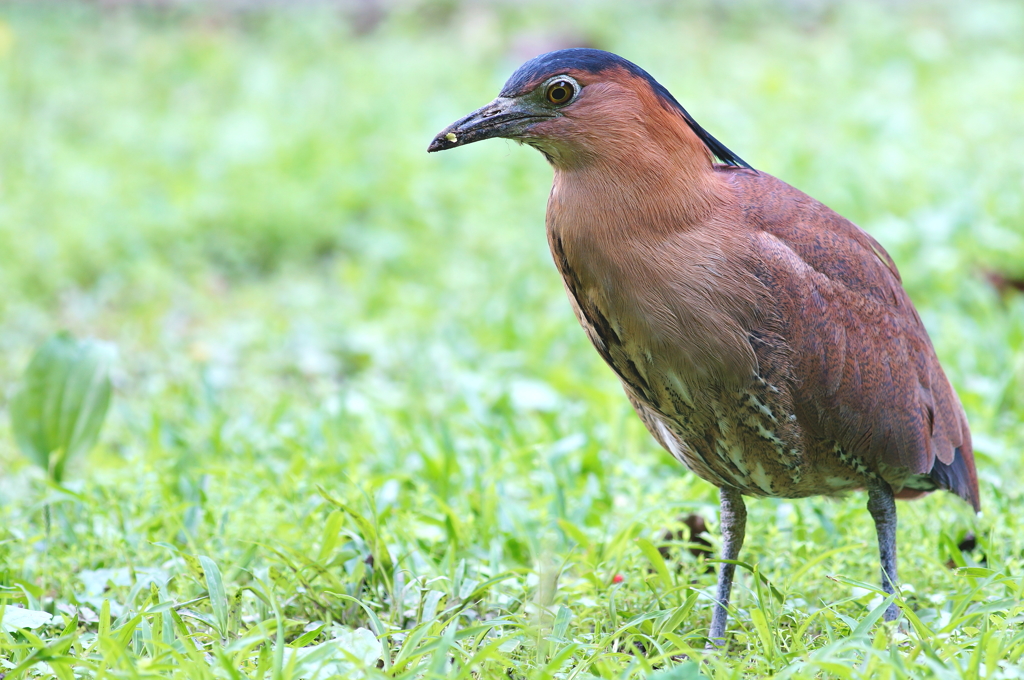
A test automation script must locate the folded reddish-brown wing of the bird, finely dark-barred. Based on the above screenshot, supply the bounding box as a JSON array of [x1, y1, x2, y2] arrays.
[[740, 174, 978, 507]]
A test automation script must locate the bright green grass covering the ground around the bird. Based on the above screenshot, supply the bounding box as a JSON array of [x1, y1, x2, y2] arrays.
[[0, 0, 1024, 680]]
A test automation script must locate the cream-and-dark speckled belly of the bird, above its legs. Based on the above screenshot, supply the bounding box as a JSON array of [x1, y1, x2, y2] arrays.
[[548, 241, 873, 498]]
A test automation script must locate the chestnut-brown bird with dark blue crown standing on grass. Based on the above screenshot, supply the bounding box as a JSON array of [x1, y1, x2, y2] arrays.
[[428, 48, 981, 648]]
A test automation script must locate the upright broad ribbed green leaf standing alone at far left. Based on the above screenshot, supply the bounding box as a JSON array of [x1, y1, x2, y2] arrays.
[[10, 332, 113, 482]]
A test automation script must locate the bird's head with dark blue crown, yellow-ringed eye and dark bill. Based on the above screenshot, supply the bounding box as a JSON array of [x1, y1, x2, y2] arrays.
[[427, 48, 750, 173]]
